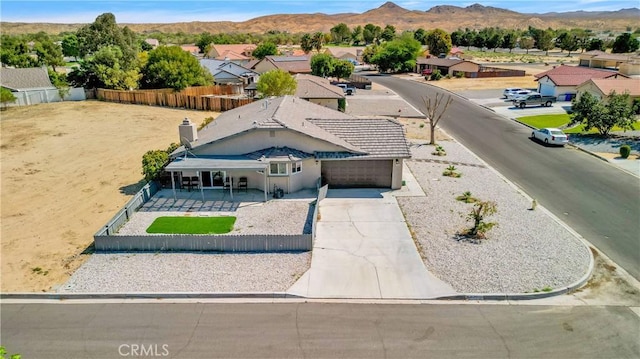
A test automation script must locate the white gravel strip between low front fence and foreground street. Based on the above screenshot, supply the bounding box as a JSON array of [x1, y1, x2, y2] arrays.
[[58, 252, 311, 293]]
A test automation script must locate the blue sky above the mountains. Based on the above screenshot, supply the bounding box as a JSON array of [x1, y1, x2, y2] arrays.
[[0, 0, 639, 23]]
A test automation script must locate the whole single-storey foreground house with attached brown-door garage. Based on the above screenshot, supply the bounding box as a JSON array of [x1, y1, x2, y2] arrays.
[[165, 96, 410, 200]]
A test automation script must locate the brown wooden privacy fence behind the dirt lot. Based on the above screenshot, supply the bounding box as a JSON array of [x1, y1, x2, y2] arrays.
[[96, 85, 253, 111]]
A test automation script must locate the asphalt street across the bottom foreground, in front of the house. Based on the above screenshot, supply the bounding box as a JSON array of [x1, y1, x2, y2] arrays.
[[1, 303, 640, 359]]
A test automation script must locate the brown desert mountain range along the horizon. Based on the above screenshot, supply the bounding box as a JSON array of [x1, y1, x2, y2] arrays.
[[0, 2, 640, 34]]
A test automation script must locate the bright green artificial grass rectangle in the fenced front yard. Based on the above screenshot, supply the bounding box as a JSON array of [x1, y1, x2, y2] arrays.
[[147, 217, 236, 234]]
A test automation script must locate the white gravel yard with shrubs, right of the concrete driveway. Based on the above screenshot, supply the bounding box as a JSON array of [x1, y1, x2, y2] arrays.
[[397, 141, 590, 293]]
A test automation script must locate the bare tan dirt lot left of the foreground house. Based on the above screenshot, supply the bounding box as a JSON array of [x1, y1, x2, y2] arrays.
[[0, 101, 217, 292]]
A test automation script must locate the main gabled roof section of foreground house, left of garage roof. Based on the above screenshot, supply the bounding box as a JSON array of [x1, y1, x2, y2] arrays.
[[193, 96, 362, 153]]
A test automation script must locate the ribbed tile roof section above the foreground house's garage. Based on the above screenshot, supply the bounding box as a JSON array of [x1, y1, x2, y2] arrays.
[[309, 118, 411, 158]]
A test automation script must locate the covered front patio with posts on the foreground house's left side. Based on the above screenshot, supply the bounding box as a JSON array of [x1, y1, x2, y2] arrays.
[[165, 156, 269, 203]]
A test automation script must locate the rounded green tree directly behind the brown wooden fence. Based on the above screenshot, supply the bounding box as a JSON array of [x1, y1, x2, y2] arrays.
[[141, 46, 213, 91]]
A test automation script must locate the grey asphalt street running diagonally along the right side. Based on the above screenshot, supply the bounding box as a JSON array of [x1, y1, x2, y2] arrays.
[[368, 75, 640, 280]]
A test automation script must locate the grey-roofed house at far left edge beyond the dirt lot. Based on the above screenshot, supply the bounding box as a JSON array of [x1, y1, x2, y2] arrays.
[[0, 67, 66, 106]]
